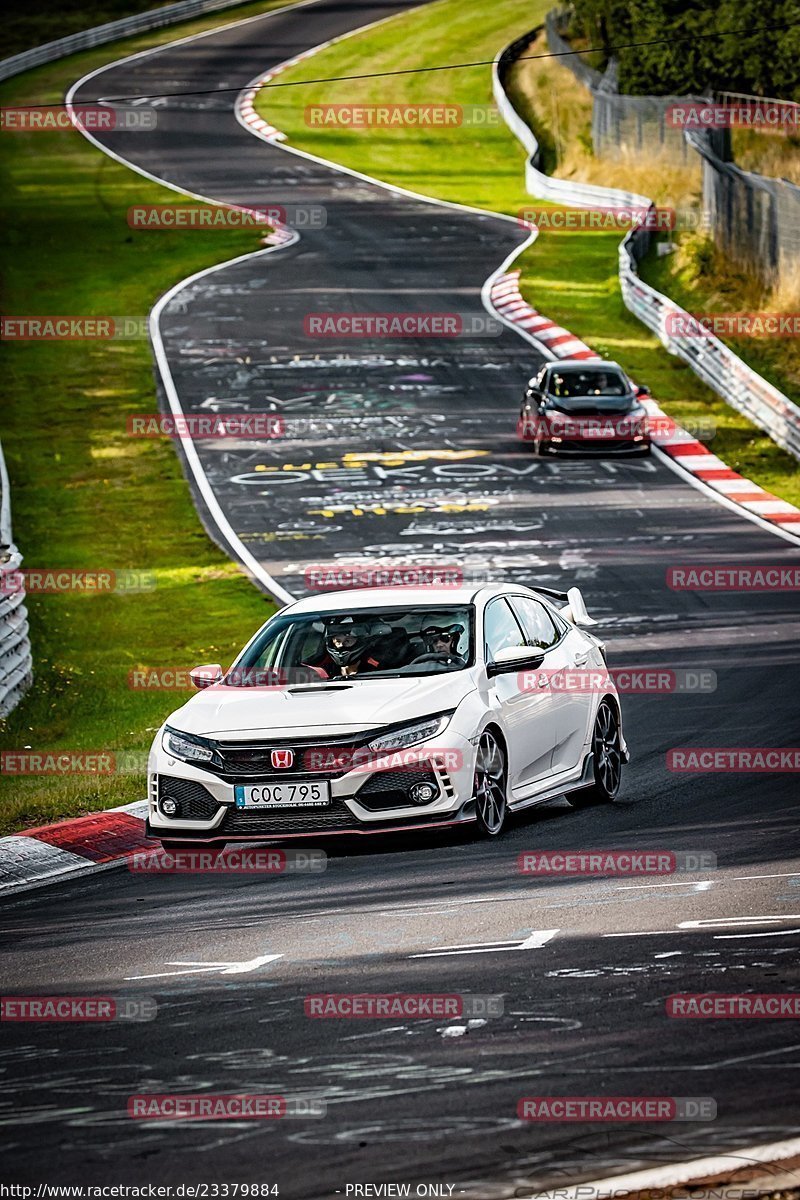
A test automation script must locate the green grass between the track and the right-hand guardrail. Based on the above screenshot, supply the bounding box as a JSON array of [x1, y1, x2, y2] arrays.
[[257, 0, 800, 503]]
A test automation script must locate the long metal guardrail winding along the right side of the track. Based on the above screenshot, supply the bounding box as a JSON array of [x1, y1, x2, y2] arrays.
[[492, 26, 800, 458]]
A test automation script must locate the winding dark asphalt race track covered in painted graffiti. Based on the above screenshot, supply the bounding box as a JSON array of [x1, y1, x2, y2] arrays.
[[2, 0, 800, 1200]]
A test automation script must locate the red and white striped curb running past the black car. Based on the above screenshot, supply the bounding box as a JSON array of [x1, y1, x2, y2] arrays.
[[489, 270, 800, 533]]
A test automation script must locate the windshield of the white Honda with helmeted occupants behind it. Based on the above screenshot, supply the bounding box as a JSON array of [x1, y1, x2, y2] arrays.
[[227, 605, 474, 686]]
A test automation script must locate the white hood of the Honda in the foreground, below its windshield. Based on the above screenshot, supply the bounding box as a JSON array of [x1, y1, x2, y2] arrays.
[[167, 670, 475, 739]]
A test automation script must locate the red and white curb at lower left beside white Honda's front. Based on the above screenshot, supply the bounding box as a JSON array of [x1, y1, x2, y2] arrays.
[[0, 800, 157, 896]]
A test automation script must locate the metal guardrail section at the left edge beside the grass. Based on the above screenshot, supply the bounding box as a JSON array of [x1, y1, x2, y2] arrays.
[[0, 446, 34, 716]]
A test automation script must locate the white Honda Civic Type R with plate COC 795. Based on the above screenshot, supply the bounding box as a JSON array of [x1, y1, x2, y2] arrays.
[[148, 584, 630, 848]]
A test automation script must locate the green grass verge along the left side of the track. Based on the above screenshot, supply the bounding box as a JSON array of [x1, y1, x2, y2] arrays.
[[0, 4, 293, 834]]
